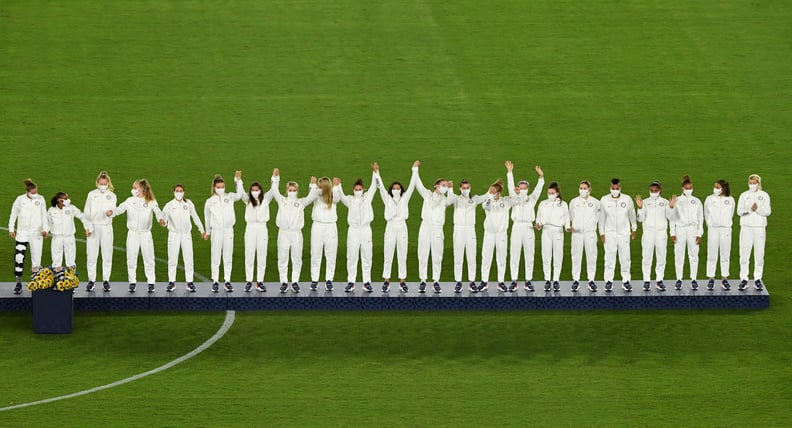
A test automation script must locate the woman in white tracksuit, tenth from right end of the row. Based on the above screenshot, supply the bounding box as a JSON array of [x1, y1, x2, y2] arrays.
[[448, 180, 487, 293]]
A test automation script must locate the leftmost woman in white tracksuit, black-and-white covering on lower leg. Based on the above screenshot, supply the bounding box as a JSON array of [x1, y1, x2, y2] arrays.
[[8, 178, 49, 294]]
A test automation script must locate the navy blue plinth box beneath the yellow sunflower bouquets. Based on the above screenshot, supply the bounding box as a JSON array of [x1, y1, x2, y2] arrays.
[[32, 288, 74, 334]]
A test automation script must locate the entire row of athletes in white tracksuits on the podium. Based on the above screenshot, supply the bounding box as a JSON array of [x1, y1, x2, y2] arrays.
[[9, 161, 771, 293]]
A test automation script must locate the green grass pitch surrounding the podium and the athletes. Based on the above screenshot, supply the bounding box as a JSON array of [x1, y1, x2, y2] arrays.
[[0, 0, 792, 426]]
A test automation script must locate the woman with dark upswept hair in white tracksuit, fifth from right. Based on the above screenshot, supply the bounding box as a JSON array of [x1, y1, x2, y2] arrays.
[[599, 178, 638, 293]]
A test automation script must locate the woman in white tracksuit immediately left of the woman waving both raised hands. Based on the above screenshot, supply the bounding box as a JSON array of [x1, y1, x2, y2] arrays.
[[480, 180, 522, 293]]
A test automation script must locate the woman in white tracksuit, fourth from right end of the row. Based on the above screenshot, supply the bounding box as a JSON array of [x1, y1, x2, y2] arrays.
[[635, 181, 672, 291]]
